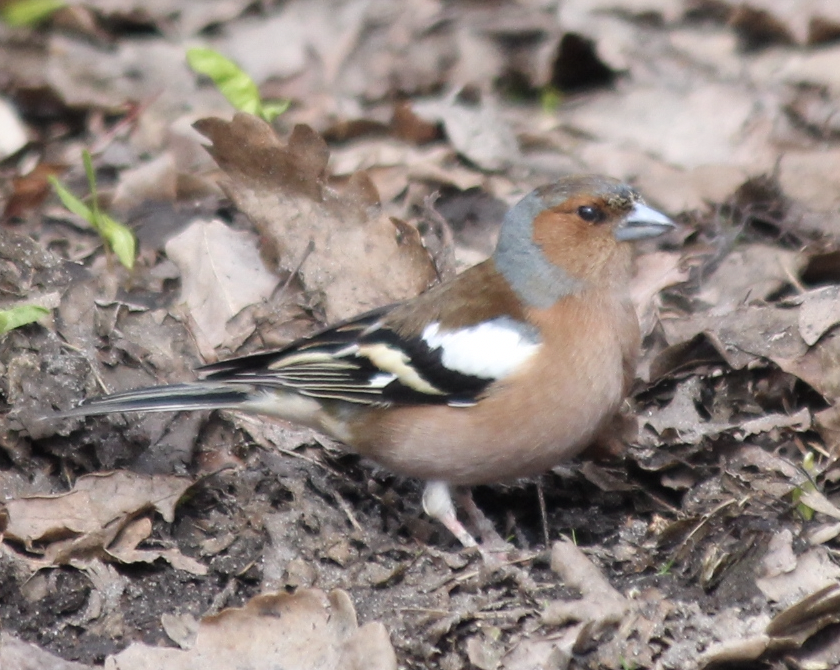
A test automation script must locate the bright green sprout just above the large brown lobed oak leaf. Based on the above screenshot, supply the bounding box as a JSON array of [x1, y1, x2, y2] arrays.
[[187, 48, 290, 123]]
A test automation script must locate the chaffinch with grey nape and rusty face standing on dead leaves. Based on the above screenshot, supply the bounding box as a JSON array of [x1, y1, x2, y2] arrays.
[[57, 175, 674, 546]]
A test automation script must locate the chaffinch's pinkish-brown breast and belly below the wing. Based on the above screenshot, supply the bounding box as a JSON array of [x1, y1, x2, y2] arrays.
[[348, 290, 639, 485]]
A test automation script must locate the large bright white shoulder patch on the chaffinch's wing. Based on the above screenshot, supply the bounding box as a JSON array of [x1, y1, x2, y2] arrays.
[[422, 317, 540, 379]]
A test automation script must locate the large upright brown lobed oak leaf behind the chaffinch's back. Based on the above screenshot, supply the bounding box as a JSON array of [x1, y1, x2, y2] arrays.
[[195, 114, 435, 321]]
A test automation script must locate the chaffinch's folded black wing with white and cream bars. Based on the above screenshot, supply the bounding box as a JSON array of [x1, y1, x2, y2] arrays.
[[201, 307, 540, 406]]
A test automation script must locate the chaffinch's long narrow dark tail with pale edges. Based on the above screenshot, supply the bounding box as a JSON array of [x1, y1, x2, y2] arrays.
[[49, 382, 254, 419]]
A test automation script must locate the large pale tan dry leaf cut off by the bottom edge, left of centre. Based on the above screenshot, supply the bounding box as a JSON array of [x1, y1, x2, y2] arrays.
[[105, 589, 397, 670]]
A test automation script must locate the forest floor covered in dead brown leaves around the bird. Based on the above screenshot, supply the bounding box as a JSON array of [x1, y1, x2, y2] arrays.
[[0, 0, 840, 670]]
